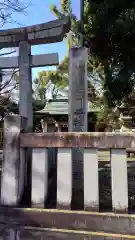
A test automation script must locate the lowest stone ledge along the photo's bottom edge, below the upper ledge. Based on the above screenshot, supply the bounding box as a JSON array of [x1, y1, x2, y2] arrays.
[[8, 228, 135, 240]]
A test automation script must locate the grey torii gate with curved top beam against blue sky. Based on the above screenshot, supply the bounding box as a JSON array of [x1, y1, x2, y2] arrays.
[[0, 17, 70, 131]]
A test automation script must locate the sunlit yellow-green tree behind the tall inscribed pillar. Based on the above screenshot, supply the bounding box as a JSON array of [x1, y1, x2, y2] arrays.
[[34, 0, 104, 105]]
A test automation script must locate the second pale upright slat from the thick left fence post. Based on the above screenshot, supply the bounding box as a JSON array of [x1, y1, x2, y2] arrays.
[[57, 148, 72, 209]]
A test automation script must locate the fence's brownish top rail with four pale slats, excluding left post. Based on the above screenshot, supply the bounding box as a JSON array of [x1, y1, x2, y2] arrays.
[[20, 128, 132, 212]]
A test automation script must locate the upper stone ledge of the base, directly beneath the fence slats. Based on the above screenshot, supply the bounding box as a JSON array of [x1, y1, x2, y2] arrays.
[[0, 207, 135, 236]]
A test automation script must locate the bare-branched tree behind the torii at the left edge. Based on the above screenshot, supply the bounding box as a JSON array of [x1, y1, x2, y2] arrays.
[[0, 0, 28, 118]]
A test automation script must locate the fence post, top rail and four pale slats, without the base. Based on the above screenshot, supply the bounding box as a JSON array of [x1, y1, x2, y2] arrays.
[[1, 116, 135, 212]]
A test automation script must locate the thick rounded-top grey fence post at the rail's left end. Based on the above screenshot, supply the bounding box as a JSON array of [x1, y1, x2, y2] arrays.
[[1, 115, 27, 205]]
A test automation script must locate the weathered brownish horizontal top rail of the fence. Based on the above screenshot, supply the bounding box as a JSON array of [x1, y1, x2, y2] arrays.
[[20, 132, 135, 149]]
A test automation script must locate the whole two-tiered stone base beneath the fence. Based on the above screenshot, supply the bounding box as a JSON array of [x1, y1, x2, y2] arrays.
[[0, 207, 135, 237]]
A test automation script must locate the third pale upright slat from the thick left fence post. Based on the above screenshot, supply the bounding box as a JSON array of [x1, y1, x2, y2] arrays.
[[84, 149, 99, 211]]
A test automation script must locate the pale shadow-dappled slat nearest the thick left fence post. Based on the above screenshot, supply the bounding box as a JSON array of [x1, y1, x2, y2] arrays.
[[32, 148, 48, 208]]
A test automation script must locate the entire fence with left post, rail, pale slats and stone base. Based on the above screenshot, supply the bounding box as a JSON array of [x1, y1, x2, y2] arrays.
[[0, 116, 135, 240]]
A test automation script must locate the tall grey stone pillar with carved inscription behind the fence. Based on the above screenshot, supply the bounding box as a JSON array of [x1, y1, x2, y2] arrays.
[[69, 47, 88, 209]]
